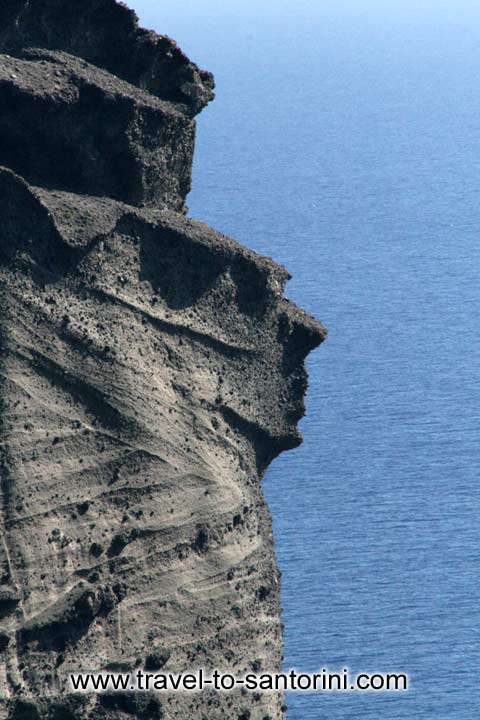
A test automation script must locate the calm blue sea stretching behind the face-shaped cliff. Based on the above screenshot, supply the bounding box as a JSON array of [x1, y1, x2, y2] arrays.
[[133, 0, 480, 720]]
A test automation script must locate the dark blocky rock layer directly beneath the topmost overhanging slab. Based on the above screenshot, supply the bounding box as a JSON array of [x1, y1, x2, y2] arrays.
[[0, 50, 195, 211]]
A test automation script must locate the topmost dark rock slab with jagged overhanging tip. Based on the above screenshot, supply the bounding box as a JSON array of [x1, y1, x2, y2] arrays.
[[0, 0, 214, 114]]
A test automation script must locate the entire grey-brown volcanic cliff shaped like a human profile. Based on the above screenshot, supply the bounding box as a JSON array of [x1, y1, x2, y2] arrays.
[[0, 0, 325, 720]]
